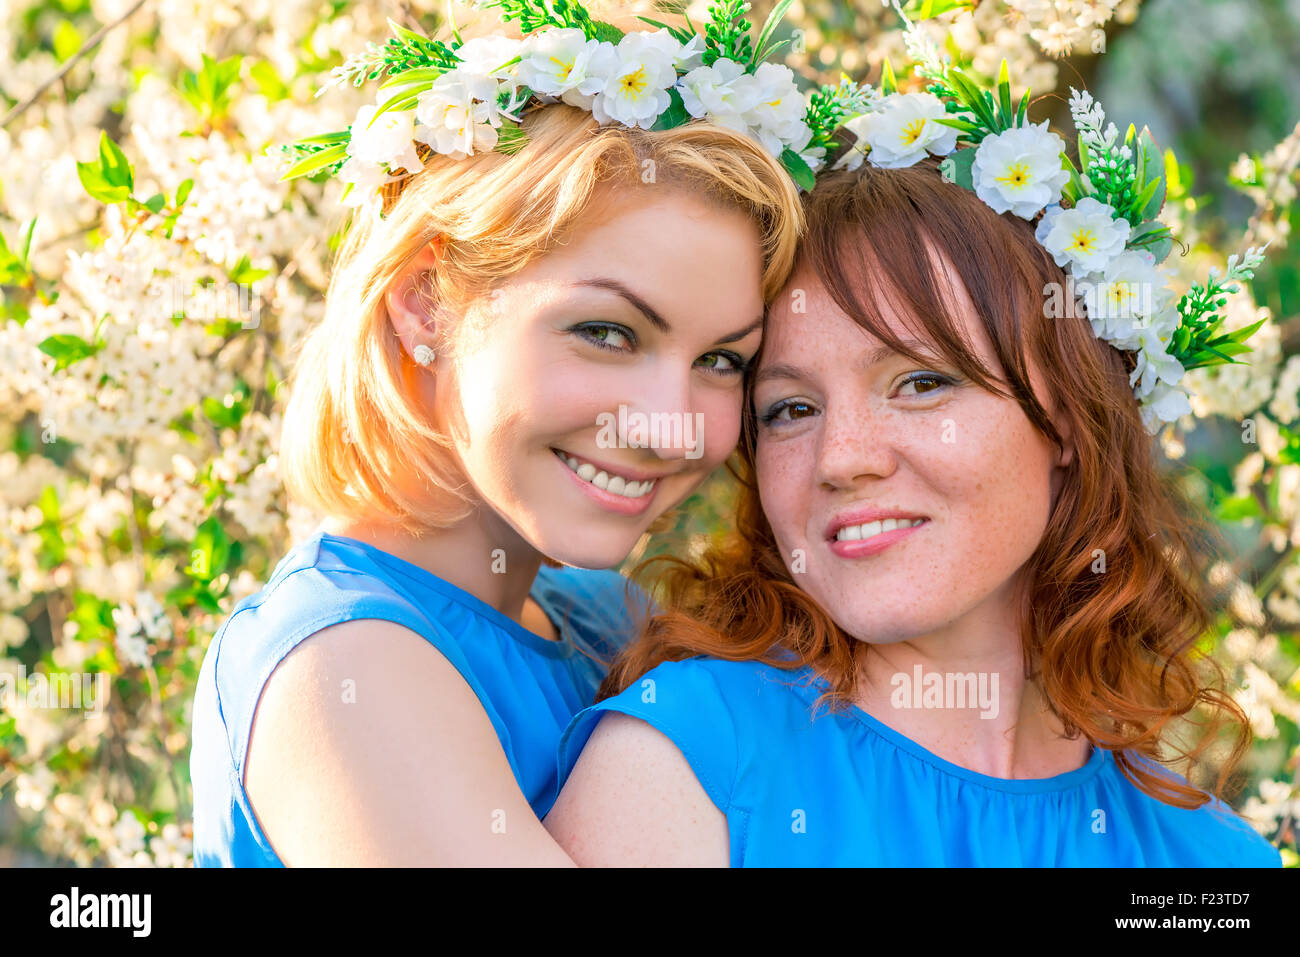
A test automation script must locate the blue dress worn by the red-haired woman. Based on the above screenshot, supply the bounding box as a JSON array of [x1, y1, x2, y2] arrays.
[[558, 657, 1281, 867]]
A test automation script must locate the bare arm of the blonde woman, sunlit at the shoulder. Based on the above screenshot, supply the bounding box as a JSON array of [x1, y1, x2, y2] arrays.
[[244, 619, 572, 866]]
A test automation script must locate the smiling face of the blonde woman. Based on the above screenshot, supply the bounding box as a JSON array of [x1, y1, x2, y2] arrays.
[[434, 190, 763, 568]]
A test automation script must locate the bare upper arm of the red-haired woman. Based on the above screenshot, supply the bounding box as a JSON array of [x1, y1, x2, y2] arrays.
[[543, 711, 731, 867]]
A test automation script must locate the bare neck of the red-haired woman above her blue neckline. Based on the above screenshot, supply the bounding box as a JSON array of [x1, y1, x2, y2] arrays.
[[854, 587, 1091, 779]]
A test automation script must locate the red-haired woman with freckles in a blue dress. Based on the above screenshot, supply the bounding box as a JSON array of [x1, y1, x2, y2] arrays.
[[545, 160, 1279, 866]]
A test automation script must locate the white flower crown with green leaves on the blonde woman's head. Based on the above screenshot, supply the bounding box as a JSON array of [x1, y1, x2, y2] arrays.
[[268, 0, 866, 208]]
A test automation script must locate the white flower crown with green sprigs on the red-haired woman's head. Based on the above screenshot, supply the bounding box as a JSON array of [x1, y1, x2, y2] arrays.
[[835, 0, 1268, 434]]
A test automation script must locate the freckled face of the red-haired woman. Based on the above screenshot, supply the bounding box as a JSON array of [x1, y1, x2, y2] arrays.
[[754, 252, 1067, 644]]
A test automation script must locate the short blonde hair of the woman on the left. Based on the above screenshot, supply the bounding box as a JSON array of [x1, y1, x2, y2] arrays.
[[280, 67, 803, 534]]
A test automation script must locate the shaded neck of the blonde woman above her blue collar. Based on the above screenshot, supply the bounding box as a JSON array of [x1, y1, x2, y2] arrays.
[[320, 507, 542, 627]]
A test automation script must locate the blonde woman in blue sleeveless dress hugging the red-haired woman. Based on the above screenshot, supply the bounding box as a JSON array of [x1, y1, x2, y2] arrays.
[[191, 1, 802, 866]]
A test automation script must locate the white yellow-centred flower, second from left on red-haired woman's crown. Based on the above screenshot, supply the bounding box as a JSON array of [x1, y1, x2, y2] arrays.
[[971, 120, 1070, 220]]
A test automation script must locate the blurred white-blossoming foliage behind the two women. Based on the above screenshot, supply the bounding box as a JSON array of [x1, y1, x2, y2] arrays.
[[0, 0, 1300, 866]]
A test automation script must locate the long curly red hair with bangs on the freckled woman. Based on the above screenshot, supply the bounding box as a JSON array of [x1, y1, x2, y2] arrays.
[[597, 160, 1251, 807]]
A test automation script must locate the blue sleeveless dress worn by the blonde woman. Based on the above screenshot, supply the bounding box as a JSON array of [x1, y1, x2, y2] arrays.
[[190, 531, 645, 867]]
